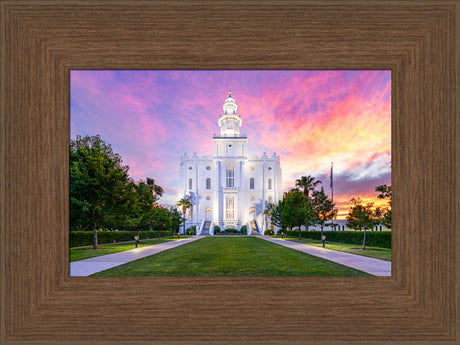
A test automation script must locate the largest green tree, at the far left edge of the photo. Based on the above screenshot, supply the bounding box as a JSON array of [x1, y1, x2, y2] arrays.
[[69, 135, 131, 249]]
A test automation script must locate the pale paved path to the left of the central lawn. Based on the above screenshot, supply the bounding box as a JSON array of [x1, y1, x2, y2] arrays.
[[70, 236, 203, 277]]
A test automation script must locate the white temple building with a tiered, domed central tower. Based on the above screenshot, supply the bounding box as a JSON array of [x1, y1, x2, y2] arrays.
[[179, 91, 283, 235]]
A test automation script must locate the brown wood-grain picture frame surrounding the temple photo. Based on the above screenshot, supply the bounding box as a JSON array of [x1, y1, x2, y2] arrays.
[[0, 1, 460, 344]]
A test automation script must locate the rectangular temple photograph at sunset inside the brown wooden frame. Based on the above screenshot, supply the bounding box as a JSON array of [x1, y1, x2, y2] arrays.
[[69, 70, 391, 277]]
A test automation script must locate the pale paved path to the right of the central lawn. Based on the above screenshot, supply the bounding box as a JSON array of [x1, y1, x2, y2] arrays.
[[258, 236, 391, 277]]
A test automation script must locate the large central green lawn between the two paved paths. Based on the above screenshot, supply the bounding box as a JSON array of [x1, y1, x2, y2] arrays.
[[93, 237, 369, 277]]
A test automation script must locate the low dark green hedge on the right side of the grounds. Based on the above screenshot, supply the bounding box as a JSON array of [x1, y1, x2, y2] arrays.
[[287, 230, 391, 248]]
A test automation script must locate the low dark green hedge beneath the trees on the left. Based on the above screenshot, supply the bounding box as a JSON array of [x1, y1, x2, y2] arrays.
[[70, 230, 172, 248]]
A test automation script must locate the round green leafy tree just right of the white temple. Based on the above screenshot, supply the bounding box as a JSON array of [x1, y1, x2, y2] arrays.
[[281, 190, 313, 239]]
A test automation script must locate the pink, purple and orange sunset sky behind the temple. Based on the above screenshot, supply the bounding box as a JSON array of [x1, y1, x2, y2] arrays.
[[70, 70, 391, 219]]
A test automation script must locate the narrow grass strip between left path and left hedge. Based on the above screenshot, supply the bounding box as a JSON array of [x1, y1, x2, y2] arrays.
[[70, 236, 190, 262]]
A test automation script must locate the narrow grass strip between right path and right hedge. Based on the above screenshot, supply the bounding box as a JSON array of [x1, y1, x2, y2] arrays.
[[276, 236, 391, 261]]
